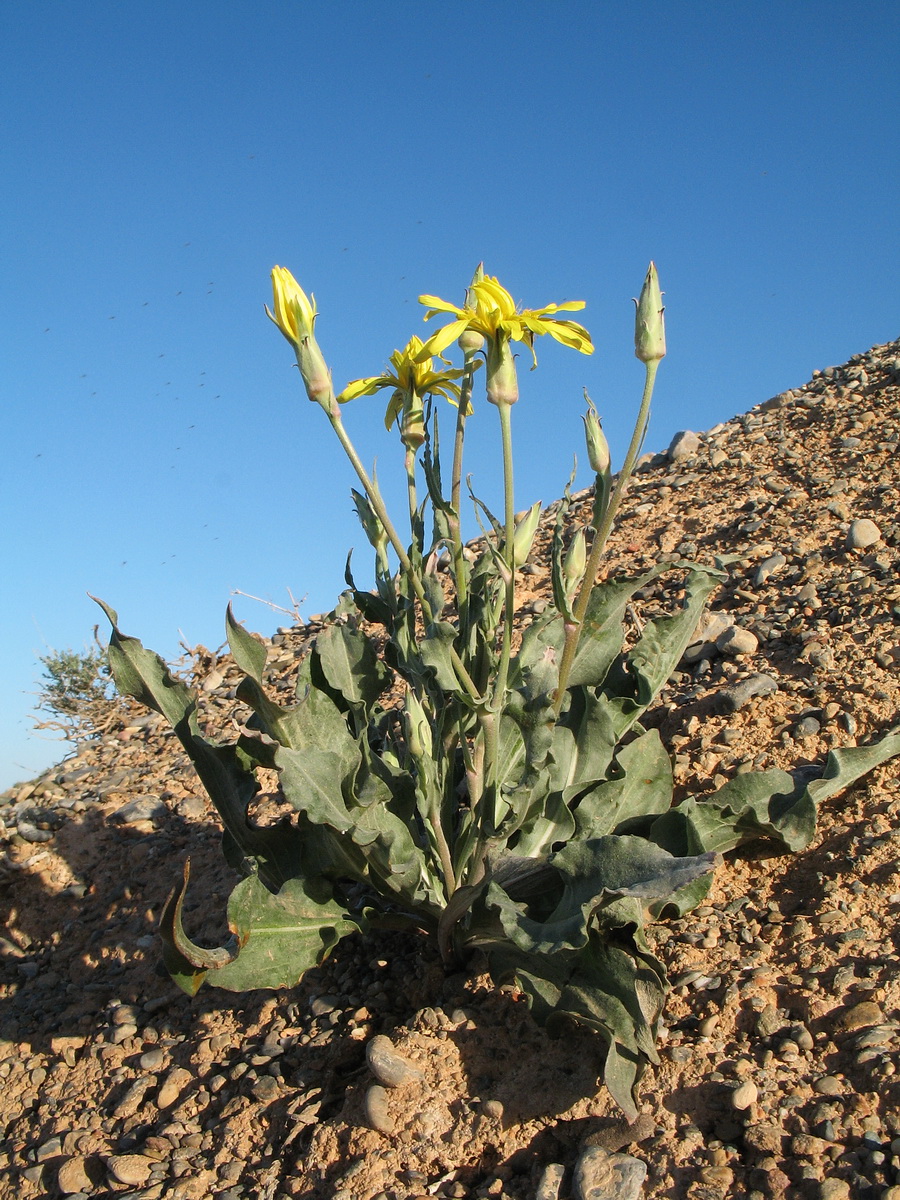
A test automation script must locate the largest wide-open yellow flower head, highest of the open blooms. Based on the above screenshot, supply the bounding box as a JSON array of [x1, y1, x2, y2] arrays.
[[419, 275, 594, 366]]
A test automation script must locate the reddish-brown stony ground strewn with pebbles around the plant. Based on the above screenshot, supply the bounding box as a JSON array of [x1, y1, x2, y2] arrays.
[[0, 342, 900, 1200]]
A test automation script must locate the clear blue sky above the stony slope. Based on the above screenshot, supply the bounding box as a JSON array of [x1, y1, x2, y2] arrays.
[[0, 0, 900, 787]]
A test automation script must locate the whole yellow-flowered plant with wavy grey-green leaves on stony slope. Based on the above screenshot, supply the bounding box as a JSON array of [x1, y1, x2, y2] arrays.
[[95, 264, 900, 1115]]
